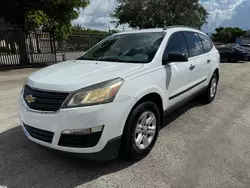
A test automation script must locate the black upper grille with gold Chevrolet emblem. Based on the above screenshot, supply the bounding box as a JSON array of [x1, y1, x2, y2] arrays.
[[23, 85, 69, 111]]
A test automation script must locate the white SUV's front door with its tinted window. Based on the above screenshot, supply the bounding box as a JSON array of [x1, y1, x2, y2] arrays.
[[164, 32, 191, 106]]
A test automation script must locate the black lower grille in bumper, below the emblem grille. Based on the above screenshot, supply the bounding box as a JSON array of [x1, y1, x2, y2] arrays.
[[24, 124, 54, 143]]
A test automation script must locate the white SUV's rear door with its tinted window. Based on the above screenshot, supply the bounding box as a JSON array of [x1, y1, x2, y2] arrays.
[[184, 31, 209, 92]]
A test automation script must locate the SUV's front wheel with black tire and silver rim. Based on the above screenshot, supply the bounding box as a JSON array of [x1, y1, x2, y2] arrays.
[[120, 101, 161, 161]]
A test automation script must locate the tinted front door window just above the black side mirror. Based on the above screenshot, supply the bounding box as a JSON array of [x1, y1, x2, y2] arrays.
[[164, 32, 189, 57]]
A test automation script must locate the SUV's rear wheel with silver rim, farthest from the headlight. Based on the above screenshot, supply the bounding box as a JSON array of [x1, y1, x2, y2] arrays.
[[202, 73, 218, 104]]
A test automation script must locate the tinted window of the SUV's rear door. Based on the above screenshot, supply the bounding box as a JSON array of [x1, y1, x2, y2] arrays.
[[184, 32, 204, 57]]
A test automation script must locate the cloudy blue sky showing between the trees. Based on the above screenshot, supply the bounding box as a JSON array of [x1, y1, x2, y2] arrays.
[[73, 0, 250, 33]]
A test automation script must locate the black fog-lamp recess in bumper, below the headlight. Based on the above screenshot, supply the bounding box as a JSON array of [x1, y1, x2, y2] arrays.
[[58, 132, 102, 148]]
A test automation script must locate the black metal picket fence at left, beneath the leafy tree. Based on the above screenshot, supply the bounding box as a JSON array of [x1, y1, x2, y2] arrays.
[[0, 24, 56, 69]]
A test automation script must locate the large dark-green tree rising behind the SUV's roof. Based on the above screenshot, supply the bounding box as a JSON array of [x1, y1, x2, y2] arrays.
[[112, 0, 208, 29]]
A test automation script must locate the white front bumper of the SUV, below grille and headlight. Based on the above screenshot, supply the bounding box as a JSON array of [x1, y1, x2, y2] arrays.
[[19, 94, 136, 159]]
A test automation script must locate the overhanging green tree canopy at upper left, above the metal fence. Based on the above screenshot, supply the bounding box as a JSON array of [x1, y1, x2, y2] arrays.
[[0, 0, 89, 40]]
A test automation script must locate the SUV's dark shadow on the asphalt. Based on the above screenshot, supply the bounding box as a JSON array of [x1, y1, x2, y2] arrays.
[[0, 100, 203, 188]]
